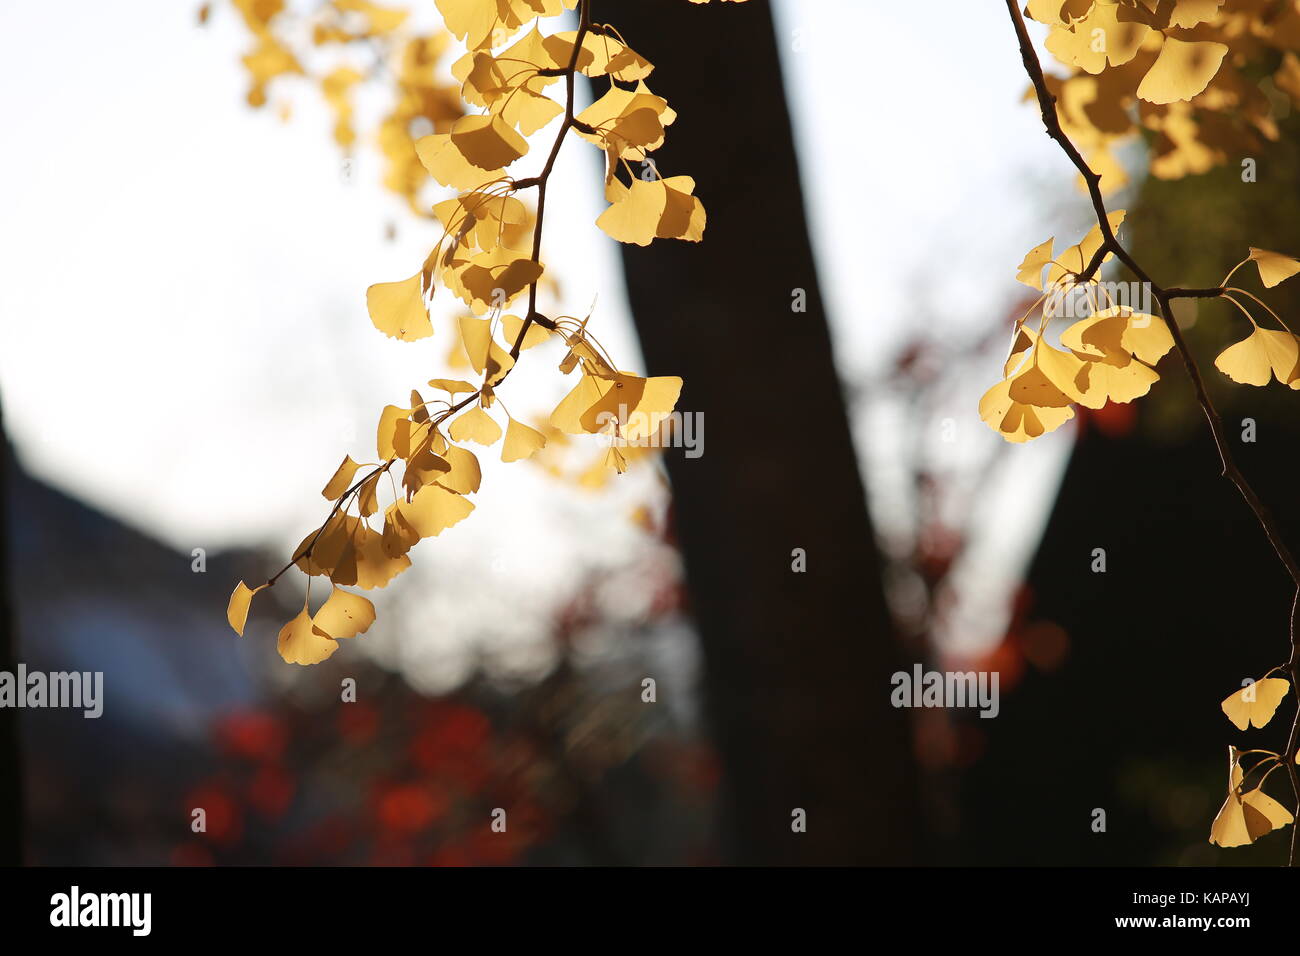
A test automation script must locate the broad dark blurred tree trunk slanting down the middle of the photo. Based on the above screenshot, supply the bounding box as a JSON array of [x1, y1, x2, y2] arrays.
[[605, 0, 917, 864]]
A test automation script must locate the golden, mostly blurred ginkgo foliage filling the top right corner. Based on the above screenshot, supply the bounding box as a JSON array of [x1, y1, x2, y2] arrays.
[[1026, 0, 1300, 190]]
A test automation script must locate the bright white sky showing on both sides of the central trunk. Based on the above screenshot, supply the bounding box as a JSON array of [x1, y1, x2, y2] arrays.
[[0, 0, 1089, 666]]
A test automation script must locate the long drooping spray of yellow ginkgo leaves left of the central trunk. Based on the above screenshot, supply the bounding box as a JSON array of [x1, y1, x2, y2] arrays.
[[228, 0, 742, 665]]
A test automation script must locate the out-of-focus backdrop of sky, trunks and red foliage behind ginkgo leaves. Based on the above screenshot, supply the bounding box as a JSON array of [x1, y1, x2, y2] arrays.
[[0, 0, 1300, 865]]
